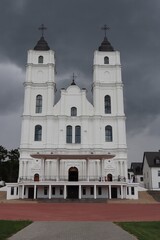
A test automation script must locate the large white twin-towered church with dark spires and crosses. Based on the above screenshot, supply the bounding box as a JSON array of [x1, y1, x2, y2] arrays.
[[7, 25, 138, 200]]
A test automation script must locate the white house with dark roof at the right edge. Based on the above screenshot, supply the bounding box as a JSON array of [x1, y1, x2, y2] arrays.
[[143, 152, 160, 190]]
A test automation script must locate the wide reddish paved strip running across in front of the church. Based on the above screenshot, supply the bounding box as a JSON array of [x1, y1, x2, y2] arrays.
[[0, 203, 160, 221]]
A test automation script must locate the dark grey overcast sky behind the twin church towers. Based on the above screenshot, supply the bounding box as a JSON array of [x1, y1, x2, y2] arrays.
[[0, 0, 160, 165]]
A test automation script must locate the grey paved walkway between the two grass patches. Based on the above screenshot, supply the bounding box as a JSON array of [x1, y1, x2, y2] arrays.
[[9, 222, 137, 240]]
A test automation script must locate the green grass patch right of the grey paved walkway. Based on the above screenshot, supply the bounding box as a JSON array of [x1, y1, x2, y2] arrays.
[[116, 222, 160, 240]]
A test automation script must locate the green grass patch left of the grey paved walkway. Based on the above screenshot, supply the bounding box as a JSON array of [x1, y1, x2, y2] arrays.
[[0, 220, 32, 240]]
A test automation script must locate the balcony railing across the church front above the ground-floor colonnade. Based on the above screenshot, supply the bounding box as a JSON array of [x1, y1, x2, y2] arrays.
[[19, 175, 126, 182]]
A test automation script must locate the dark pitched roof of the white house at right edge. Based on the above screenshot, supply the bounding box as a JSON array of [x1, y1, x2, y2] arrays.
[[143, 152, 160, 167]]
